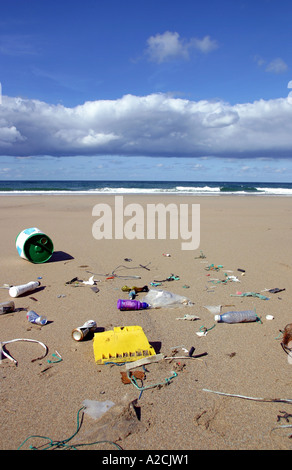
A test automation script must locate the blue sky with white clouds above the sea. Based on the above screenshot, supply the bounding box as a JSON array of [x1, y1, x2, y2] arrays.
[[0, 0, 292, 182]]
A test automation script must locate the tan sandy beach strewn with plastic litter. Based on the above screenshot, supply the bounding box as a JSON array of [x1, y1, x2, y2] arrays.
[[0, 195, 292, 451]]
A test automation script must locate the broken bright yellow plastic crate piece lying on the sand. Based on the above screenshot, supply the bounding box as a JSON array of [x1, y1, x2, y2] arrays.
[[93, 326, 156, 364]]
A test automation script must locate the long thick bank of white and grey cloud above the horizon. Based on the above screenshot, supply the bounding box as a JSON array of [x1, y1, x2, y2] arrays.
[[0, 94, 292, 161]]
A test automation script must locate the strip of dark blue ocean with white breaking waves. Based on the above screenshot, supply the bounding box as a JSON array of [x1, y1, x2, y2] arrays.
[[0, 180, 292, 196]]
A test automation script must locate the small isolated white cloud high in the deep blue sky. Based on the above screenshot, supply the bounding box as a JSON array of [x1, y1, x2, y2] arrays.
[[147, 31, 218, 63]]
